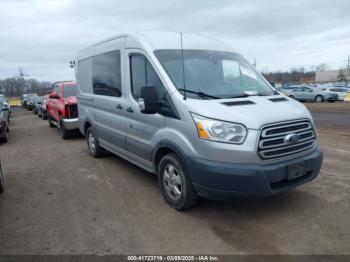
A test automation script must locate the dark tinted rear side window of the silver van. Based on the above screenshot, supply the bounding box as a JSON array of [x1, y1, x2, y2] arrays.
[[92, 50, 122, 97]]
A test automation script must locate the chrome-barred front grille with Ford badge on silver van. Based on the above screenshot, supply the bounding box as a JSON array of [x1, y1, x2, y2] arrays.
[[258, 120, 316, 159]]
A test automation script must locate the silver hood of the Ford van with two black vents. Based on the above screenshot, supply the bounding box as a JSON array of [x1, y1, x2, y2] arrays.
[[187, 95, 312, 129]]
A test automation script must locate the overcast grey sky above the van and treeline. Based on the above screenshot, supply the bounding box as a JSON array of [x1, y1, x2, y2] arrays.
[[0, 0, 350, 81]]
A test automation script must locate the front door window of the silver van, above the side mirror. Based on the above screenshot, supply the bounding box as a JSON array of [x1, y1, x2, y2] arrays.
[[130, 55, 165, 99]]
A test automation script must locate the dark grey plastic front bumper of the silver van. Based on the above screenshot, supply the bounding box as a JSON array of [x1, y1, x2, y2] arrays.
[[187, 148, 323, 199]]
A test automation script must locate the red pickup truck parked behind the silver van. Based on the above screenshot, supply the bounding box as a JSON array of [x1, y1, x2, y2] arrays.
[[46, 81, 79, 139]]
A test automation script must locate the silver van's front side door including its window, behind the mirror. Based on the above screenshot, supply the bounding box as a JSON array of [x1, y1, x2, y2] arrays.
[[125, 49, 166, 167]]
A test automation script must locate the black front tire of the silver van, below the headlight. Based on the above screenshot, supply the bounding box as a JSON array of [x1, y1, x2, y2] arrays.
[[158, 153, 199, 211]]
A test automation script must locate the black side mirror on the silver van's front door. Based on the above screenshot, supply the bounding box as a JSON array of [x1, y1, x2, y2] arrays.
[[137, 86, 162, 114]]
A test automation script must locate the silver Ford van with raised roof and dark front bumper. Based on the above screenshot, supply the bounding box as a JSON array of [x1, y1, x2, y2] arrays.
[[76, 32, 322, 210]]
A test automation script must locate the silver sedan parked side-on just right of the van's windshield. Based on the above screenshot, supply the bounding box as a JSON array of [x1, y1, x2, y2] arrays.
[[284, 86, 338, 103]]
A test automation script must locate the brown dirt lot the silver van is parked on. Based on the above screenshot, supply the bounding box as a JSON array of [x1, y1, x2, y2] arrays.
[[0, 103, 350, 254]]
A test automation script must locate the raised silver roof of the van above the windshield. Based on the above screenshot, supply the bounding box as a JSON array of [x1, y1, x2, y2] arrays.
[[79, 31, 234, 56]]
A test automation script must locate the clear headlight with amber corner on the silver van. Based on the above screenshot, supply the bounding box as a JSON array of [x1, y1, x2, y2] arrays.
[[192, 114, 247, 144]]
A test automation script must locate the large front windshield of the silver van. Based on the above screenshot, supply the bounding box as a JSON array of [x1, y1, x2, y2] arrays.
[[154, 49, 274, 98]]
